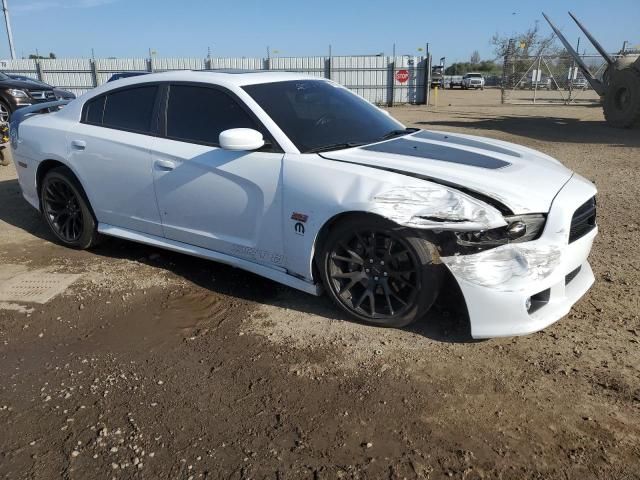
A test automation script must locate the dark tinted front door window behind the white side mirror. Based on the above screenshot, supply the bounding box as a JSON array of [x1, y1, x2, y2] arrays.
[[167, 85, 264, 145]]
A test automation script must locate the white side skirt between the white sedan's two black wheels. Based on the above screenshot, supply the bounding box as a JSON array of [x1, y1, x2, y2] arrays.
[[98, 223, 322, 295]]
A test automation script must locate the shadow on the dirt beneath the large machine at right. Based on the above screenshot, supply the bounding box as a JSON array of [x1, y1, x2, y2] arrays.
[[413, 112, 640, 147]]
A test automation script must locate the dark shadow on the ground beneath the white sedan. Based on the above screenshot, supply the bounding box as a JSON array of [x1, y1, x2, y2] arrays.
[[0, 180, 474, 343]]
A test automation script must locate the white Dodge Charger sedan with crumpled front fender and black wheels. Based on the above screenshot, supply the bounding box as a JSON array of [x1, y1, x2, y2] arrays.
[[11, 71, 597, 338]]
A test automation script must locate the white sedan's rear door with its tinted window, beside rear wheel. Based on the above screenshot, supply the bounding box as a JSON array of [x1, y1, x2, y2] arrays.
[[67, 84, 162, 235]]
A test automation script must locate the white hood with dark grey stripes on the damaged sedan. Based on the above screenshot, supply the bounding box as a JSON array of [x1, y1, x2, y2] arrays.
[[322, 130, 573, 214]]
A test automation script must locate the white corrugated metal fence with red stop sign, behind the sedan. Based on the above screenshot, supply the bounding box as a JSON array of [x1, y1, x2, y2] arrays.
[[0, 55, 429, 105]]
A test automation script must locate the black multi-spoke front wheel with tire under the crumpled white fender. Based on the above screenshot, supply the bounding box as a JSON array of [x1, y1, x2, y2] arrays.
[[318, 215, 442, 327]]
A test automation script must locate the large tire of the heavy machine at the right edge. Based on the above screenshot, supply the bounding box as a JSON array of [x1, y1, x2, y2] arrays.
[[603, 67, 640, 128]]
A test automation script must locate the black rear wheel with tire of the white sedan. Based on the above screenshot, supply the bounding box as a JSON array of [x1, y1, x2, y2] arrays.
[[40, 167, 99, 250]]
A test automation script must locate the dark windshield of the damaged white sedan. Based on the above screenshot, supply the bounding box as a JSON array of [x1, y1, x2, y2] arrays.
[[243, 80, 404, 153]]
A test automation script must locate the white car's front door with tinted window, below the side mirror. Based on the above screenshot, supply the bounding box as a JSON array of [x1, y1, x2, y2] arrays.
[[152, 83, 284, 265]]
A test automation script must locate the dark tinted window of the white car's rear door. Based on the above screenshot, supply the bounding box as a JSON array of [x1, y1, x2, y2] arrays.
[[102, 85, 158, 133]]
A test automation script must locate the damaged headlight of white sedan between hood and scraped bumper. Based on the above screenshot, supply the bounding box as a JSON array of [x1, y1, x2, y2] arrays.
[[456, 213, 546, 247]]
